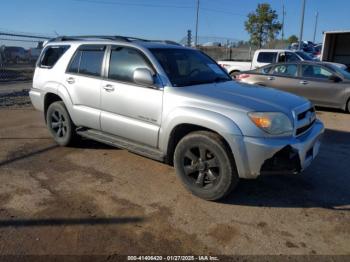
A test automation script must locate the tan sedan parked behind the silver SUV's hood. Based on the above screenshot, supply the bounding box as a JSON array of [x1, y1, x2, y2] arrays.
[[237, 62, 350, 112]]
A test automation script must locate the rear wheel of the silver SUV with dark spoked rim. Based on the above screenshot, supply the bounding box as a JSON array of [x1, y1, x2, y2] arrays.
[[46, 101, 76, 146]]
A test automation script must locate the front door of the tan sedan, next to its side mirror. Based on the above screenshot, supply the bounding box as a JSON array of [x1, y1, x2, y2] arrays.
[[299, 64, 344, 107]]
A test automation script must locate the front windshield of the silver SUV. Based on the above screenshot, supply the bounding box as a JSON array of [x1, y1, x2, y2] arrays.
[[150, 48, 232, 86]]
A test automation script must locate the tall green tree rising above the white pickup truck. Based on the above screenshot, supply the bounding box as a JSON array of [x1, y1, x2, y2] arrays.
[[245, 3, 282, 48]]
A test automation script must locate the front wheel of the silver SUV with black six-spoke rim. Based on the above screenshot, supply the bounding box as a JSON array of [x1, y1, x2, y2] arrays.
[[174, 131, 239, 200]]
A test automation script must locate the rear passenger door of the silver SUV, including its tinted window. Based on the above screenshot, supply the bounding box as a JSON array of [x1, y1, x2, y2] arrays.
[[65, 45, 106, 129]]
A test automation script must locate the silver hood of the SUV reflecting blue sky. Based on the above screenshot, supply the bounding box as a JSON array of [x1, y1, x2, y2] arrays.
[[174, 81, 309, 115]]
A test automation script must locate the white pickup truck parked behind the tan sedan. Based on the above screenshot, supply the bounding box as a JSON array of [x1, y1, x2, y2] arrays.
[[218, 49, 313, 77]]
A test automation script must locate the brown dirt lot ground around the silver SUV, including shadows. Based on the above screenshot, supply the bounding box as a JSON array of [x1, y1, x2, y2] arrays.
[[0, 85, 350, 255]]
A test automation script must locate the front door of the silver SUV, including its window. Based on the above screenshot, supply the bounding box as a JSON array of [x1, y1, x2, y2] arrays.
[[101, 46, 163, 147]]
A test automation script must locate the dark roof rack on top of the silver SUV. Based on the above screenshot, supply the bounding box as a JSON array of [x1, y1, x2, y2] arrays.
[[48, 35, 180, 45]]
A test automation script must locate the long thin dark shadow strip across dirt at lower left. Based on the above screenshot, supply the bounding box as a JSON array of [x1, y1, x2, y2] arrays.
[[0, 217, 145, 228]]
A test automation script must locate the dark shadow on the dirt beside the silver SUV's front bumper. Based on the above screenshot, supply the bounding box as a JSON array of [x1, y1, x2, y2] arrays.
[[221, 129, 350, 211]]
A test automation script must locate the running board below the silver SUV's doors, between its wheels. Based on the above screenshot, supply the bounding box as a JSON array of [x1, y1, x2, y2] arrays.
[[76, 128, 165, 162]]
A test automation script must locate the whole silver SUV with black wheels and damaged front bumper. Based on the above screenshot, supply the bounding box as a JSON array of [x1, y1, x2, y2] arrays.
[[30, 36, 324, 200]]
